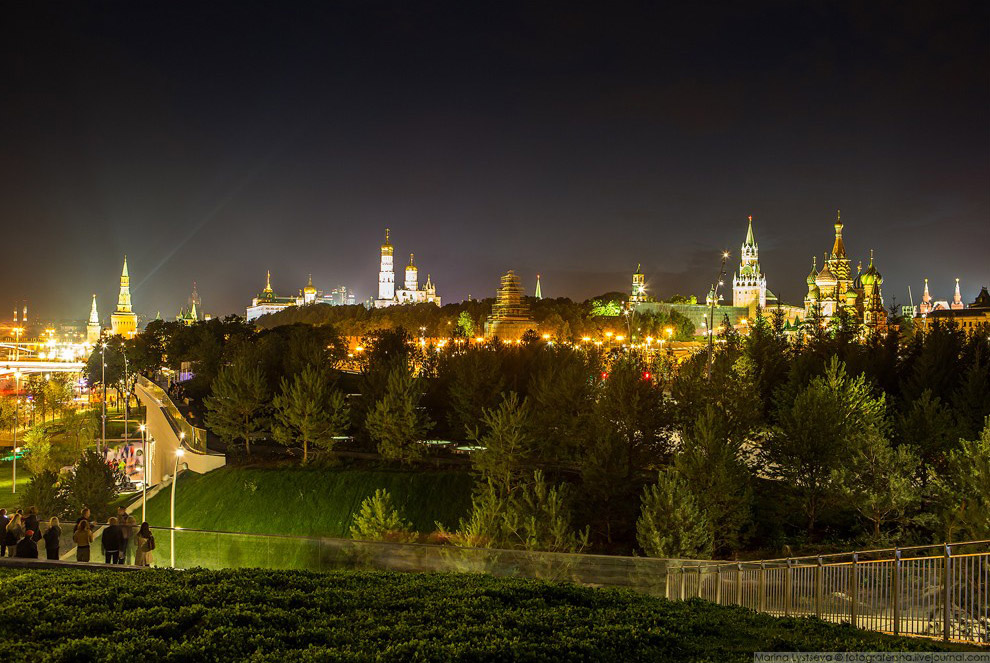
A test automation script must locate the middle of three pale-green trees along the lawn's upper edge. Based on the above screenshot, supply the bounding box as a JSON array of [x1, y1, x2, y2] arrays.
[[272, 366, 350, 463]]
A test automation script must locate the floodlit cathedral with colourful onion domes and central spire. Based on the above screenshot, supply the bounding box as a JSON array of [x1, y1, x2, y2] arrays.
[[804, 213, 887, 329]]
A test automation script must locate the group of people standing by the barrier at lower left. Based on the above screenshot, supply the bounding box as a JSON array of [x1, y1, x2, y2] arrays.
[[0, 507, 155, 566]]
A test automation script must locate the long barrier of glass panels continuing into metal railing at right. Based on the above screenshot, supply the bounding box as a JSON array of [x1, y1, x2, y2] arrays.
[[21, 523, 990, 644]]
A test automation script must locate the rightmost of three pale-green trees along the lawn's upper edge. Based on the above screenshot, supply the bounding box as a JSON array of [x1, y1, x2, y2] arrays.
[[365, 365, 433, 463]]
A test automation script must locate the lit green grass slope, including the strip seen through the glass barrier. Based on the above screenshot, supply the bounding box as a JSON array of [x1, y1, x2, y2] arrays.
[[134, 467, 474, 568]]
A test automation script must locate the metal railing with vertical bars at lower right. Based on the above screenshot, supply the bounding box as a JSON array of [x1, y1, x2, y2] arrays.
[[666, 541, 990, 644]]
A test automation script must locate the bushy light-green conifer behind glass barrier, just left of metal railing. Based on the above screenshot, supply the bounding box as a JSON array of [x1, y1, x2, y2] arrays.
[[636, 469, 712, 558]]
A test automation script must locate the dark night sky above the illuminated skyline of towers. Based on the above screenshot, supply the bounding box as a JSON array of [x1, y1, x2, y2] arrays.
[[0, 0, 990, 318]]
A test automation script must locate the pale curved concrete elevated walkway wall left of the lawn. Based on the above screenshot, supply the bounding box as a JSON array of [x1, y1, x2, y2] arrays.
[[134, 375, 227, 485]]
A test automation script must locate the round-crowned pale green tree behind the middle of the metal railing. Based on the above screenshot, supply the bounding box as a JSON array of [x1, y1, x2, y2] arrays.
[[836, 434, 921, 545]]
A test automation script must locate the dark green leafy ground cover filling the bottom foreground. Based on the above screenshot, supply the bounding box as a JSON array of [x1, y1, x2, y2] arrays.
[[0, 569, 968, 663]]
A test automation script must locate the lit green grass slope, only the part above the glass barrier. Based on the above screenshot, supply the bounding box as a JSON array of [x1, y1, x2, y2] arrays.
[[135, 467, 474, 537]]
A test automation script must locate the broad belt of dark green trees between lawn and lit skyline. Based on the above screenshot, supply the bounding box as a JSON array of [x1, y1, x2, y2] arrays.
[[87, 308, 990, 556]]
